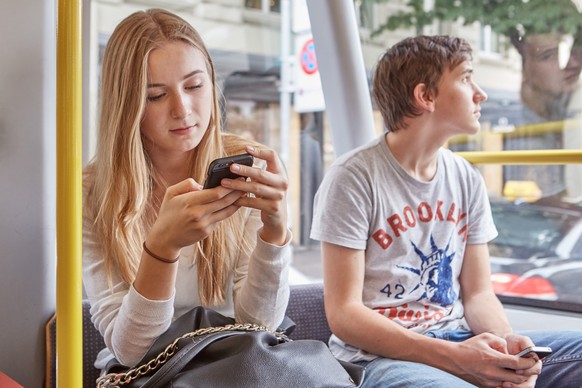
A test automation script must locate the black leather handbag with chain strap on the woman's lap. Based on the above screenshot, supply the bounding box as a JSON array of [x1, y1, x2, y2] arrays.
[[97, 307, 364, 388]]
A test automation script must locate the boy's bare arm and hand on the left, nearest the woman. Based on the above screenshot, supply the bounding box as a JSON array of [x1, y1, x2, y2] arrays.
[[322, 242, 532, 386]]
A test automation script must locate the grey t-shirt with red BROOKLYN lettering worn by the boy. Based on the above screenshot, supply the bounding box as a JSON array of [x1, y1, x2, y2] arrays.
[[311, 135, 497, 361]]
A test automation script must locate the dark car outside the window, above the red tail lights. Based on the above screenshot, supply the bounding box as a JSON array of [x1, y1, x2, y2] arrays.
[[489, 199, 582, 275]]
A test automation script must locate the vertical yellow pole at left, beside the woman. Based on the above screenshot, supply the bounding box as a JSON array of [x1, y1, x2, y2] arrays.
[[56, 0, 83, 388]]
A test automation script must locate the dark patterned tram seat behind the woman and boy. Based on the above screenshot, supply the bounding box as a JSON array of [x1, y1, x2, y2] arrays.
[[45, 283, 331, 388]]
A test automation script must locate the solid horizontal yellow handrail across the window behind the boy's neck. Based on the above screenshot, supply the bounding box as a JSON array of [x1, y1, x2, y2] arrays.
[[457, 150, 582, 164]]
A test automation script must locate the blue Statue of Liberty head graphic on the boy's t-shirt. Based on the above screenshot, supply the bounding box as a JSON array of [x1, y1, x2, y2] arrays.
[[398, 235, 457, 307]]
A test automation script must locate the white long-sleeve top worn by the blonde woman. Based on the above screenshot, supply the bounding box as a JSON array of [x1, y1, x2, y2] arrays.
[[83, 184, 291, 369]]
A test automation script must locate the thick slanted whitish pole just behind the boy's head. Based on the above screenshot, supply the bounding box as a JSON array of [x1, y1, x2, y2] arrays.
[[307, 0, 376, 156]]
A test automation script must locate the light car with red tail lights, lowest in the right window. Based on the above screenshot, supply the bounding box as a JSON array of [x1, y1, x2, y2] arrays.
[[491, 258, 582, 304]]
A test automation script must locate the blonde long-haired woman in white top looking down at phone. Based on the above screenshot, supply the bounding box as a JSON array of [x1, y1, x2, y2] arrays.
[[83, 10, 291, 368]]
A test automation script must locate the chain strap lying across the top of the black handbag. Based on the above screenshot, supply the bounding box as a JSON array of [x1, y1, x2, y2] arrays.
[[97, 323, 290, 388]]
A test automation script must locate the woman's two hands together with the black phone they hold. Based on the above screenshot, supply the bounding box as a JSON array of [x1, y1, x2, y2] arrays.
[[146, 147, 288, 257]]
